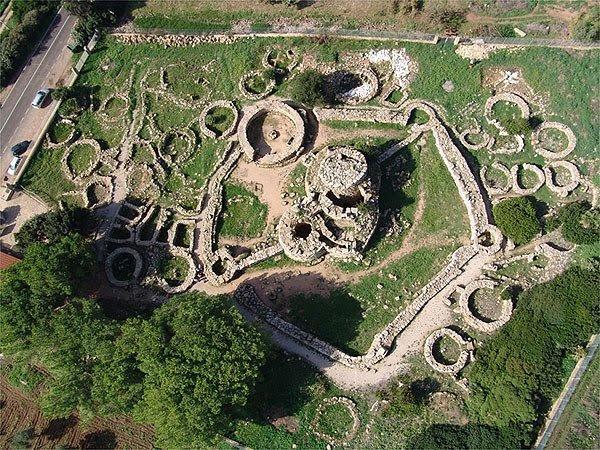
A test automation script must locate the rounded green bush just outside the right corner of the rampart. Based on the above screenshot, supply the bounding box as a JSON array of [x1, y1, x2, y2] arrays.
[[493, 197, 542, 245]]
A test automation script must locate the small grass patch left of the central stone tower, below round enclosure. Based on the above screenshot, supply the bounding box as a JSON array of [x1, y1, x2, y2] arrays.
[[218, 183, 268, 238]]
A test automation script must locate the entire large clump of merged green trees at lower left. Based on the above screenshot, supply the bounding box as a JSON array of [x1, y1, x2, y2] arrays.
[[0, 239, 267, 447]]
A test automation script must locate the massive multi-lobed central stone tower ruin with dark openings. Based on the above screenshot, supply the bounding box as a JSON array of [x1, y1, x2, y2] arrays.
[[278, 147, 380, 262]]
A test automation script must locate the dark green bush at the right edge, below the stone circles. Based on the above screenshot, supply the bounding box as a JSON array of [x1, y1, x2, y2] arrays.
[[558, 202, 600, 244]]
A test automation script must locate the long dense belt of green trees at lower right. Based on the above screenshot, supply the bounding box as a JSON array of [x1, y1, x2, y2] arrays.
[[467, 267, 600, 434]]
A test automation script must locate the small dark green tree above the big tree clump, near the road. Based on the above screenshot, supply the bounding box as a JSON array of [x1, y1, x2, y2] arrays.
[[15, 207, 90, 251]]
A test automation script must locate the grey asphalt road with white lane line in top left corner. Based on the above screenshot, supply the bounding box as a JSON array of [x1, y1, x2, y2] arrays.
[[0, 9, 76, 150]]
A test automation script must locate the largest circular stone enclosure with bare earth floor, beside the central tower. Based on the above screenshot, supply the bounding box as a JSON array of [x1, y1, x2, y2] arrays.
[[238, 101, 305, 167]]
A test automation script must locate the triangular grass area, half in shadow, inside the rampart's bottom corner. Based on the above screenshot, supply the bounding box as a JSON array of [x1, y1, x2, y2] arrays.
[[283, 247, 453, 354]]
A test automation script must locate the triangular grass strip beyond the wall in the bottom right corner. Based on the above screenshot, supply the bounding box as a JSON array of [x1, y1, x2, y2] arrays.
[[547, 353, 600, 449]]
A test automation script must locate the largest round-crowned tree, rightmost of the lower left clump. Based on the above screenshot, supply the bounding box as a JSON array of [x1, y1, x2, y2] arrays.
[[135, 293, 266, 447]]
